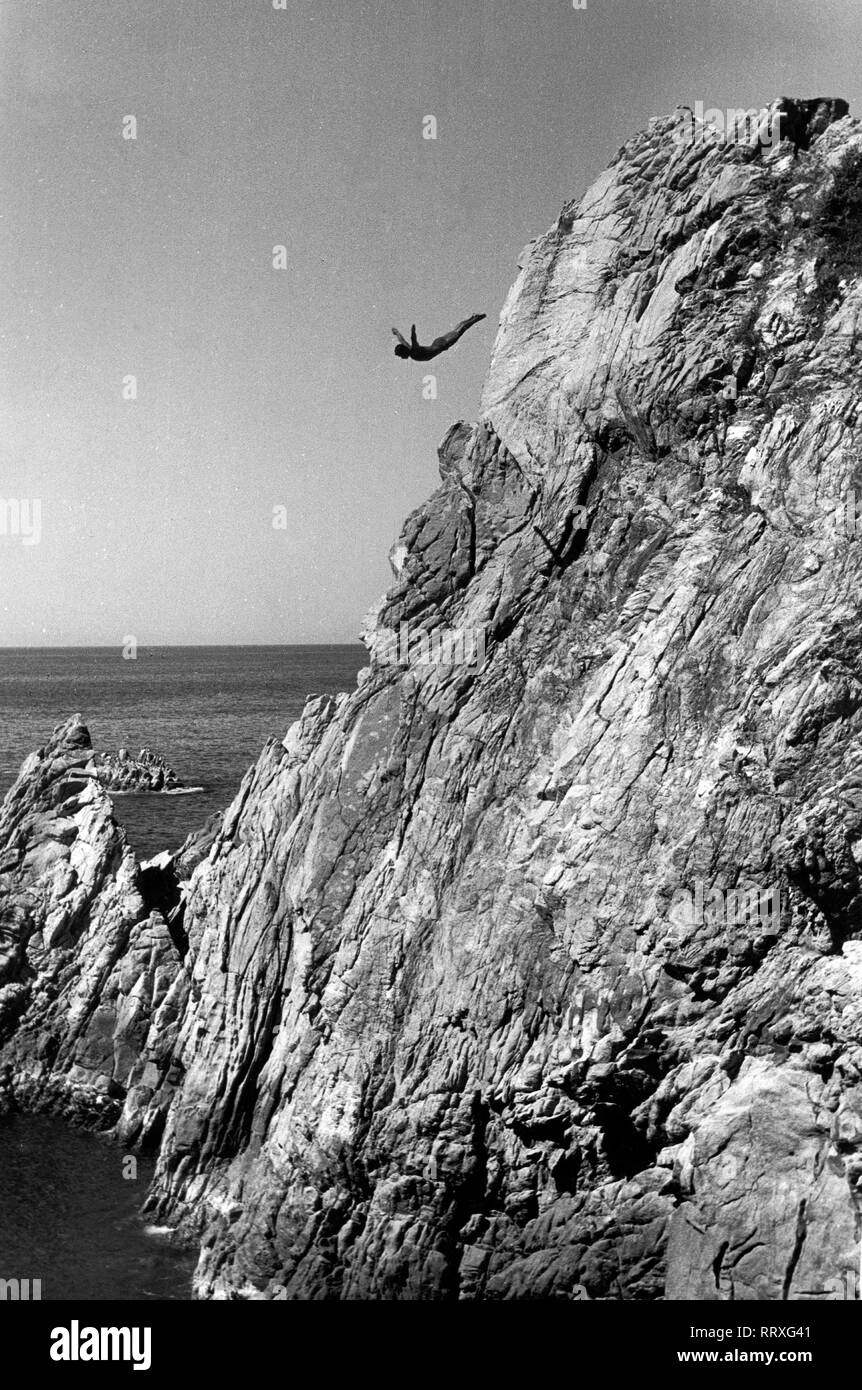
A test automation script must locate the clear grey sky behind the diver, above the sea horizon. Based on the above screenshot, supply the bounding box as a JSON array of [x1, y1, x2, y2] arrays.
[[0, 0, 862, 646]]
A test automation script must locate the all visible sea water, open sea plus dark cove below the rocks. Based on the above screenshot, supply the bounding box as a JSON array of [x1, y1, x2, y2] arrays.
[[0, 646, 366, 1301]]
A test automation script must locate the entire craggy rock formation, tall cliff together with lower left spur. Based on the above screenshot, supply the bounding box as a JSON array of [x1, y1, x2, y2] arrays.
[[0, 101, 862, 1300]]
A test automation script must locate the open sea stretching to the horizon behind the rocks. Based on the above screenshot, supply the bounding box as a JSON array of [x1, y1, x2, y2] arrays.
[[0, 645, 367, 859]]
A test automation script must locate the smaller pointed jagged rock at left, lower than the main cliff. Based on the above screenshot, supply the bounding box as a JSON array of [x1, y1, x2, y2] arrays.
[[0, 716, 186, 1141]]
